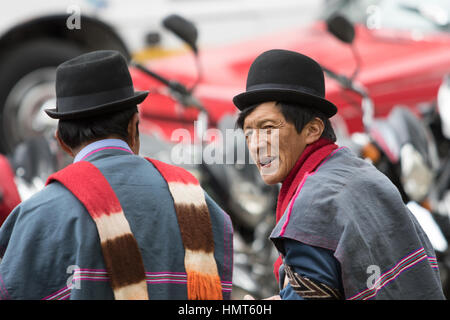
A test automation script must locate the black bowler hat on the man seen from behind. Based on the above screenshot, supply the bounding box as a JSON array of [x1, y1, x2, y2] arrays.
[[45, 50, 148, 120]]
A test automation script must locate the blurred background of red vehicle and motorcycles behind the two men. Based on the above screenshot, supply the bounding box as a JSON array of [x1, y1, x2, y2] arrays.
[[0, 0, 450, 298]]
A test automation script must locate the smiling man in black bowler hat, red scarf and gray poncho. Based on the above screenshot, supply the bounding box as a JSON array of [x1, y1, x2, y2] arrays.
[[233, 50, 444, 300]]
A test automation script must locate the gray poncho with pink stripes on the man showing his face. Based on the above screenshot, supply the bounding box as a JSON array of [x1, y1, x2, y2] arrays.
[[271, 148, 444, 299]]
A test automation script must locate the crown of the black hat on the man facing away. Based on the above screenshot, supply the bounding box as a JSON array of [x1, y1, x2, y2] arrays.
[[56, 50, 133, 97]]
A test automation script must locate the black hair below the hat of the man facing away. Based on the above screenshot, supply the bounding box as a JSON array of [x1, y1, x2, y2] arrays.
[[58, 106, 139, 149]]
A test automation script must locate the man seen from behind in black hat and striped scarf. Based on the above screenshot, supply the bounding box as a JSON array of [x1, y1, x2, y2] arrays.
[[0, 50, 233, 300]]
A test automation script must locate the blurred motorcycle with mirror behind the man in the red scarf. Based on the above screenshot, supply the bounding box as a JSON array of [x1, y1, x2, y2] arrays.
[[324, 16, 450, 296]]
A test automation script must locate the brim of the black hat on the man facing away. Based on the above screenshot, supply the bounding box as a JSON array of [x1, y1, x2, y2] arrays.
[[44, 91, 149, 120]]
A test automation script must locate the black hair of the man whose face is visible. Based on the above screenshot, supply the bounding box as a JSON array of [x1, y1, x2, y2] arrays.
[[236, 102, 336, 142]]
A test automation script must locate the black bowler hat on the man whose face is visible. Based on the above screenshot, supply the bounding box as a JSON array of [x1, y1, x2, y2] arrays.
[[233, 49, 337, 117]]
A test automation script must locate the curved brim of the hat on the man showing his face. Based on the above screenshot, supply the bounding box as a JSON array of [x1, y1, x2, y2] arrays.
[[233, 88, 337, 118]]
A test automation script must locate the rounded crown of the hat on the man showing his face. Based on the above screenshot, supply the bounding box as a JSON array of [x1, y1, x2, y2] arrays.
[[246, 49, 325, 98]]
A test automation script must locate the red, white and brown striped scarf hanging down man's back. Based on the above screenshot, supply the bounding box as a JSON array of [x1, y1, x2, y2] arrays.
[[46, 158, 222, 300]]
